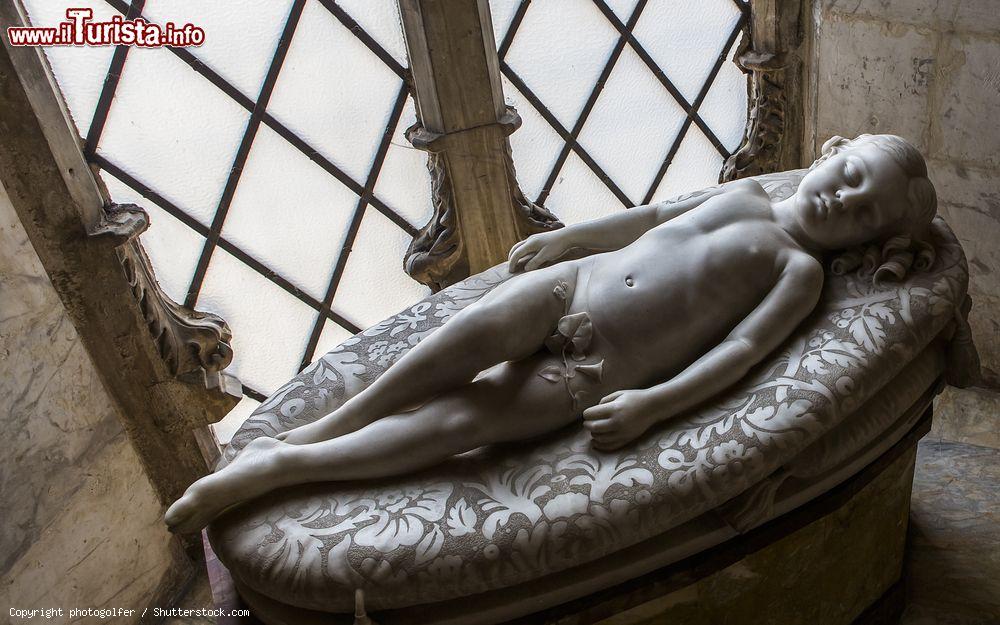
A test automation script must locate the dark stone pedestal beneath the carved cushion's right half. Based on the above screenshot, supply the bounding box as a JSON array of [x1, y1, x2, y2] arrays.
[[548, 441, 916, 625]]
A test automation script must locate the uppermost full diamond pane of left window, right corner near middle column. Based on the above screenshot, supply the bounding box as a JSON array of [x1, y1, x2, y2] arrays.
[[267, 0, 401, 184]]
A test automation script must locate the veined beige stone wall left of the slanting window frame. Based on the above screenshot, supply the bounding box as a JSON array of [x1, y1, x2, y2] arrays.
[[0, 180, 191, 623]]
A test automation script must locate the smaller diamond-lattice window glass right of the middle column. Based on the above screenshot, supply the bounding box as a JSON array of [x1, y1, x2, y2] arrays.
[[493, 0, 749, 218]]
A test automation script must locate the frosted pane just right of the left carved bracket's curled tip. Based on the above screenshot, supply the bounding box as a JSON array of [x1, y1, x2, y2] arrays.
[[198, 249, 316, 394]]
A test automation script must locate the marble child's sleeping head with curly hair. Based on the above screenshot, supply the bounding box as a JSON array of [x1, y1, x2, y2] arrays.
[[795, 135, 937, 281]]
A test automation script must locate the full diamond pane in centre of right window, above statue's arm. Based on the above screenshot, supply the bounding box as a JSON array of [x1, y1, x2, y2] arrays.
[[580, 47, 685, 203]]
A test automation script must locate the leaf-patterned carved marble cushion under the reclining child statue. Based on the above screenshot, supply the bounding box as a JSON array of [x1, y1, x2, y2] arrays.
[[209, 171, 968, 612]]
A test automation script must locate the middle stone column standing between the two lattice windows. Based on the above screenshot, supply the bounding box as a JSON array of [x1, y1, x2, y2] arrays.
[[399, 0, 562, 290]]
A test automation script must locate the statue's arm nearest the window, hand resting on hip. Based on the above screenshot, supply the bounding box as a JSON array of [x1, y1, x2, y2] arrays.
[[508, 183, 744, 273]]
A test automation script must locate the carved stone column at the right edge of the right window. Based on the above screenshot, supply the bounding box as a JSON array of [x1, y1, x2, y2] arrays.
[[719, 0, 810, 182]]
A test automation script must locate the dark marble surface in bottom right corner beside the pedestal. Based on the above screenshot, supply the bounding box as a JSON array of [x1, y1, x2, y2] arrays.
[[902, 440, 1000, 625]]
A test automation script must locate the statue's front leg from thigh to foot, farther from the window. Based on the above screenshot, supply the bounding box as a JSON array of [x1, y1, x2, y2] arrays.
[[165, 354, 576, 531]]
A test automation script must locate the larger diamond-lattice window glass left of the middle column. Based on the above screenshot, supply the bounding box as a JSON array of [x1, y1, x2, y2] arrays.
[[26, 0, 430, 440]]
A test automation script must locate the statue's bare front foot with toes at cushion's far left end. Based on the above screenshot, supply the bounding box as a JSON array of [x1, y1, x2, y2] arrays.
[[163, 437, 286, 533]]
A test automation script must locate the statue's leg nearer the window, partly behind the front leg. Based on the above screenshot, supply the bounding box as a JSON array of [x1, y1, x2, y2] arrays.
[[277, 264, 576, 445]]
